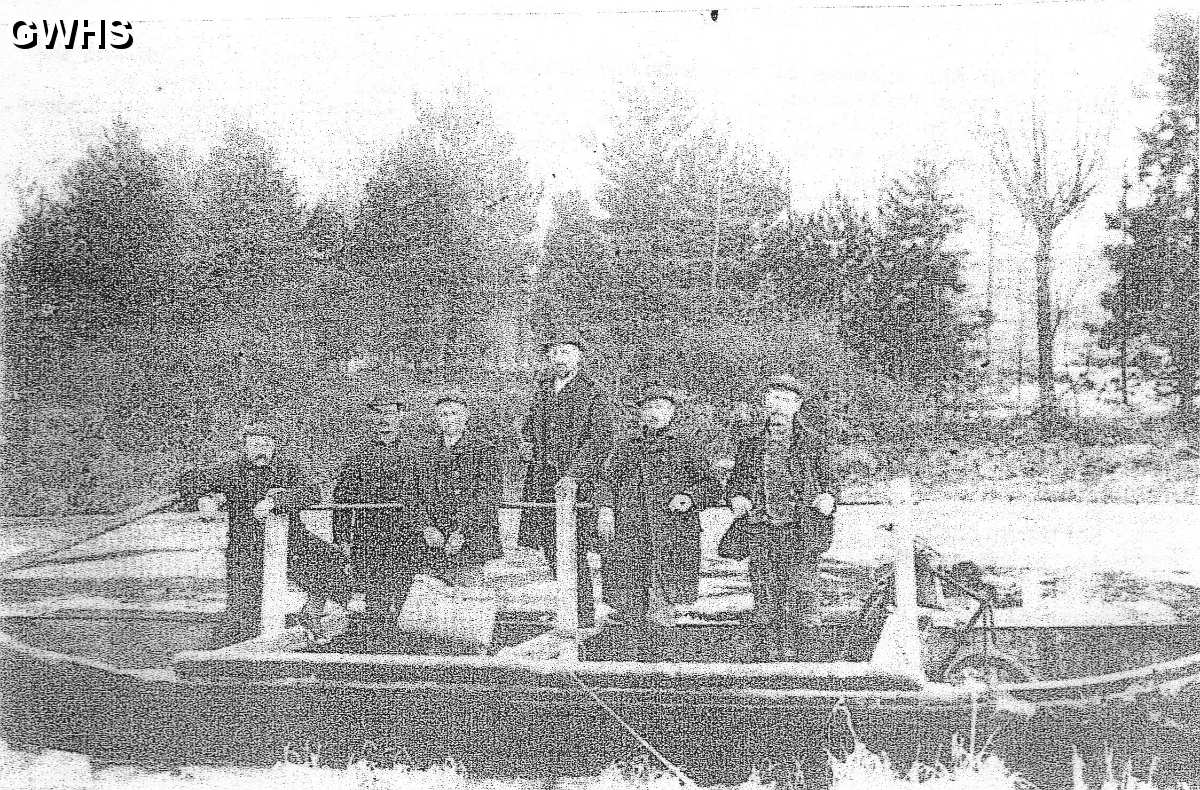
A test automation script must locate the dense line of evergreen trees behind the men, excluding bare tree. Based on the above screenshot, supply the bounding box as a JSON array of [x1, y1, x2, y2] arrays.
[[0, 14, 1200, 511]]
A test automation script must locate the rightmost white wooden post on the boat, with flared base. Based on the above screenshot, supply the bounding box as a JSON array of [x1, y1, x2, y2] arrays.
[[871, 477, 922, 674]]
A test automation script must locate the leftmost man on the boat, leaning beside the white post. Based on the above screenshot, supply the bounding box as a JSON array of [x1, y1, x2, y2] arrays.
[[179, 423, 349, 645]]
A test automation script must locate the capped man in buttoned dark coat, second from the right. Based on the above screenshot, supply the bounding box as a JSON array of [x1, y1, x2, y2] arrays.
[[596, 387, 715, 627]]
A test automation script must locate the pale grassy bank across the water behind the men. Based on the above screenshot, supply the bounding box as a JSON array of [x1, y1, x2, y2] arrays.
[[0, 391, 1200, 515]]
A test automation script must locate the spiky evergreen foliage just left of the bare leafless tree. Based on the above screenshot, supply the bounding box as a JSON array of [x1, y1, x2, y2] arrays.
[[762, 161, 977, 396]]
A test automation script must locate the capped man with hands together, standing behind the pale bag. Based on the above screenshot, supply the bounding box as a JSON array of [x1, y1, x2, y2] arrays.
[[415, 390, 503, 587]]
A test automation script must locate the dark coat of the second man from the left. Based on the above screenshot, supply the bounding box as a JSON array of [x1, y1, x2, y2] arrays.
[[334, 439, 418, 577]]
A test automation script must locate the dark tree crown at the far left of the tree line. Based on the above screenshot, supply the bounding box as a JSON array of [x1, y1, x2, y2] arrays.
[[5, 118, 182, 390]]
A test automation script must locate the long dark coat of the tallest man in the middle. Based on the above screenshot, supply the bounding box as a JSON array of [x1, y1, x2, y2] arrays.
[[517, 372, 614, 549]]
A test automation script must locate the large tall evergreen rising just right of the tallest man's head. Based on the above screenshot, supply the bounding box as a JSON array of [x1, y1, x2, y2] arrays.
[[571, 76, 787, 373]]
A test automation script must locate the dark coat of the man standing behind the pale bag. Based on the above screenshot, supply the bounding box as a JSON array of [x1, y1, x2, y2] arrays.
[[414, 427, 504, 569]]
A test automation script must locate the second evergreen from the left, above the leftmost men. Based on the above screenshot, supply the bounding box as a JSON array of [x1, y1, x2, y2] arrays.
[[187, 127, 322, 414]]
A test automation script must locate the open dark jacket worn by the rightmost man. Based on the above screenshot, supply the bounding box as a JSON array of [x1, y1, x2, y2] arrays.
[[728, 409, 839, 556]]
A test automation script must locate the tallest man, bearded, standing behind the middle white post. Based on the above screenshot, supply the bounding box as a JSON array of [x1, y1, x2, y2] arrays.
[[517, 330, 613, 627]]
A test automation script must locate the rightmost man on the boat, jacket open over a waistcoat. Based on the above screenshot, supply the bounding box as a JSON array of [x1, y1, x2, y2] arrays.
[[728, 376, 838, 654]]
